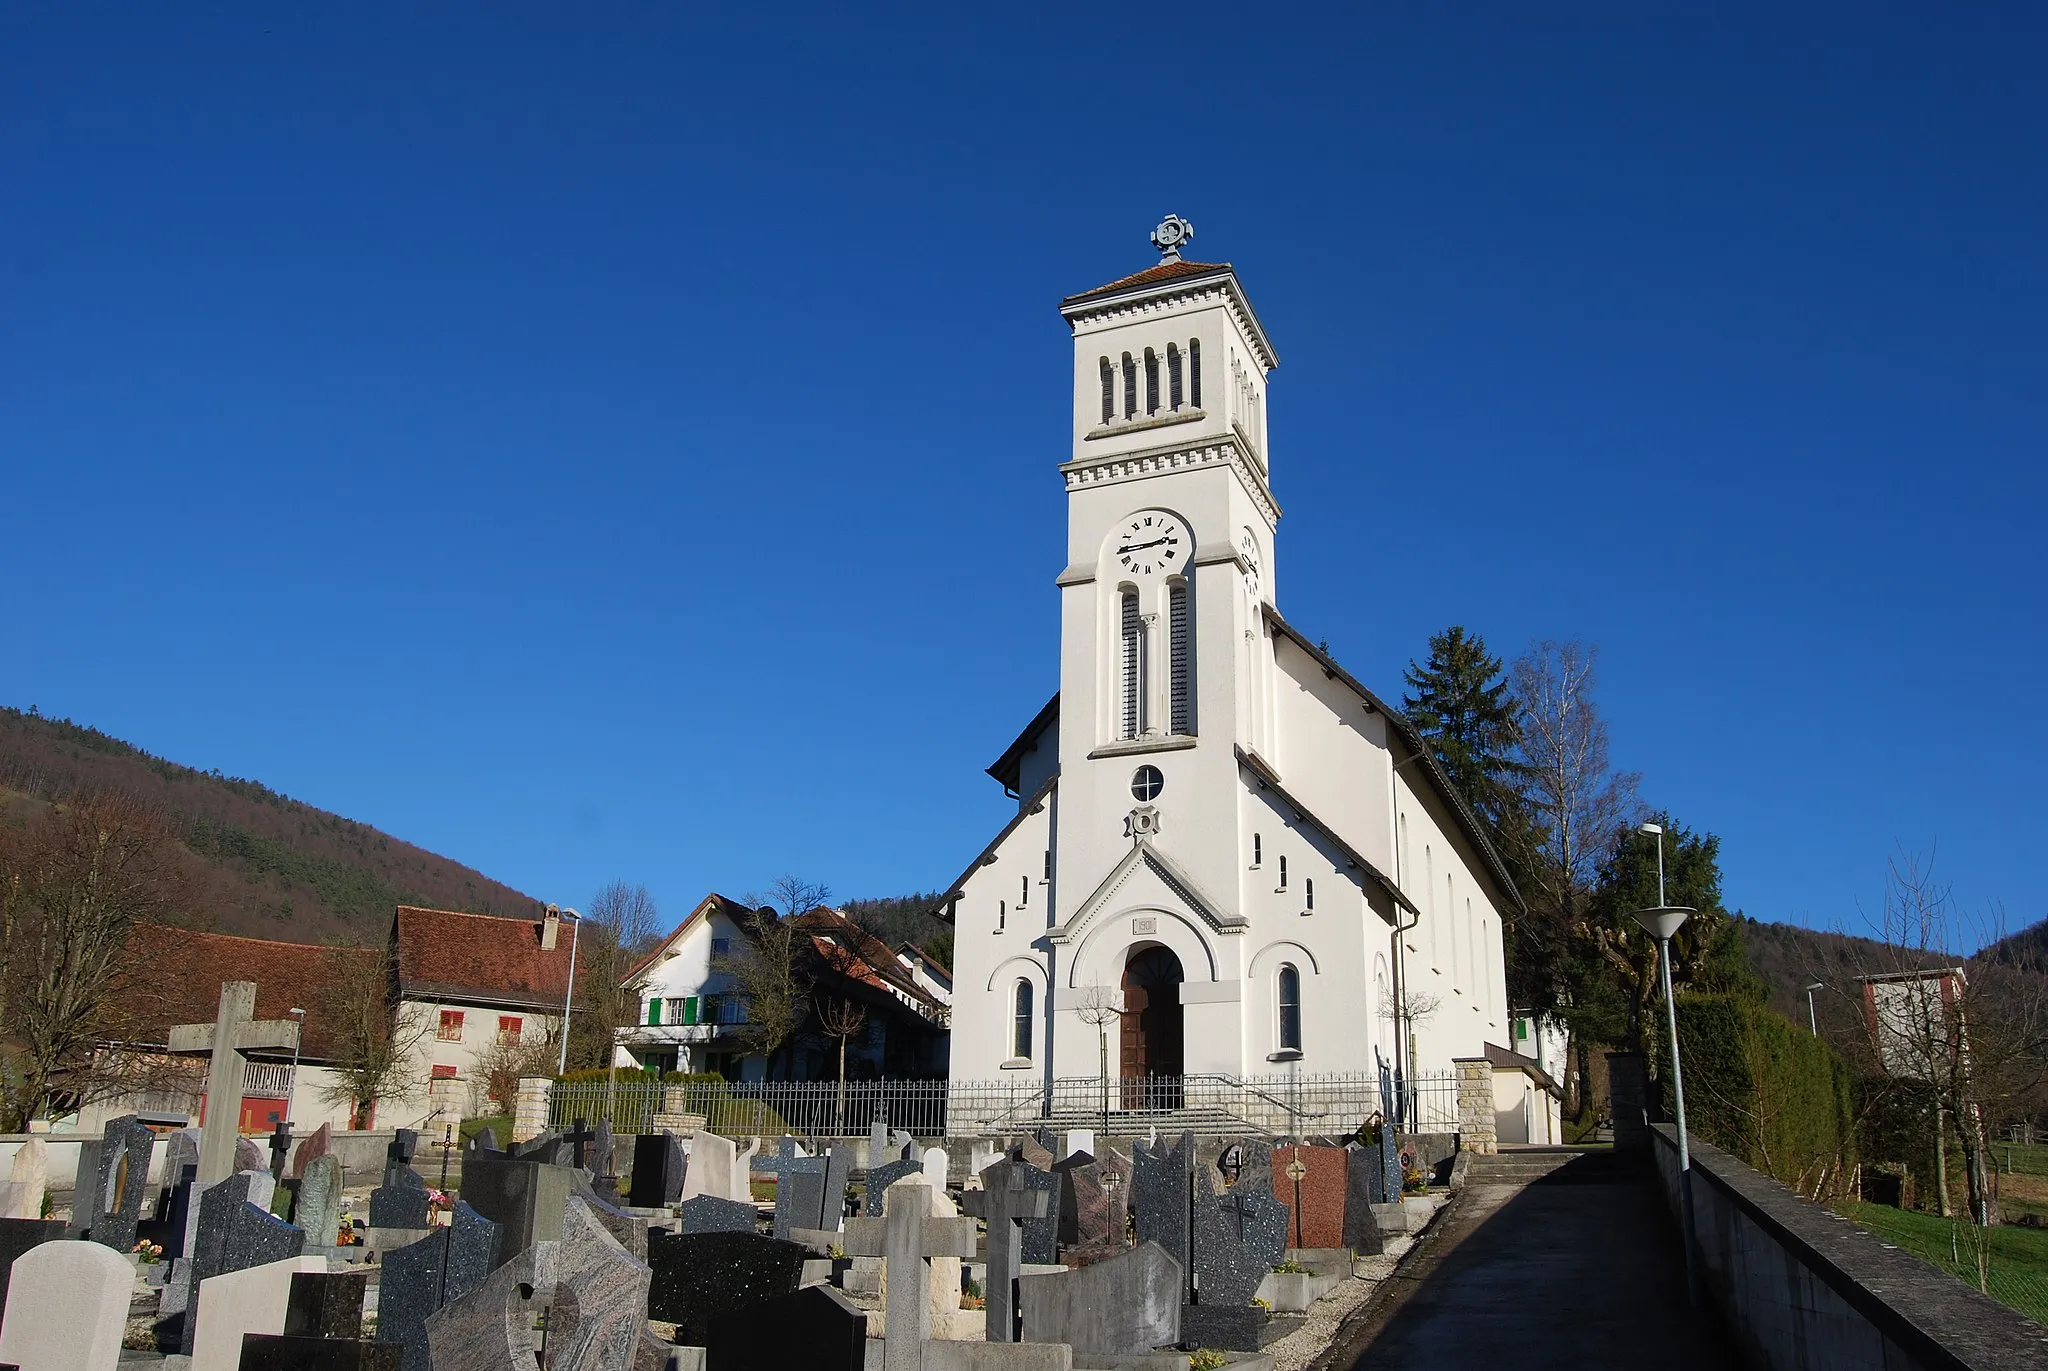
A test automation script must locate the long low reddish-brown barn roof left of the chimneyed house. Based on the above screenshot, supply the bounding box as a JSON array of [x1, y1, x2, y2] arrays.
[[129, 924, 381, 1062]]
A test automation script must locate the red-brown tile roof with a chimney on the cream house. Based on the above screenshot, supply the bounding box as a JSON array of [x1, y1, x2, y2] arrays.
[[393, 904, 575, 1008]]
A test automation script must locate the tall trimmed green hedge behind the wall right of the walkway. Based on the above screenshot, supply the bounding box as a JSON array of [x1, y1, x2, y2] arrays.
[[1653, 996, 1855, 1197]]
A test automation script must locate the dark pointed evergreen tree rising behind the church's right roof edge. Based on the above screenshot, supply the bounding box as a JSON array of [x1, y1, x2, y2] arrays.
[[1401, 623, 1522, 828]]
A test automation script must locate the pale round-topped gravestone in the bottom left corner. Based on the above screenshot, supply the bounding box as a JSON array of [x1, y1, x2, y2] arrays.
[[0, 1240, 135, 1371]]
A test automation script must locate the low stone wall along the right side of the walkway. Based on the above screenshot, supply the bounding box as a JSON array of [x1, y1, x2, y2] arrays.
[[1651, 1123, 2048, 1371]]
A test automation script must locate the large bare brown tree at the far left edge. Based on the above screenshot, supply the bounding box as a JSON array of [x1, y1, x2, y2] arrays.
[[0, 793, 186, 1131]]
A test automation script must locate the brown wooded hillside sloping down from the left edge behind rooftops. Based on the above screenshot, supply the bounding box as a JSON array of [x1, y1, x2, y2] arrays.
[[0, 707, 537, 943]]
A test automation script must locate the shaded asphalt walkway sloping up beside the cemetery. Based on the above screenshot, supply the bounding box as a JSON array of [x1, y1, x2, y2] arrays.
[[1325, 1152, 1741, 1371]]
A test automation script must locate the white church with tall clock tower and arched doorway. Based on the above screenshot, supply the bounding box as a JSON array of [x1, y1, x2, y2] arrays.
[[944, 217, 1520, 1107]]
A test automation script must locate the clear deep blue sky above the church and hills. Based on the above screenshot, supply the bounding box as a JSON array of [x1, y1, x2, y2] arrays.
[[0, 4, 2048, 942]]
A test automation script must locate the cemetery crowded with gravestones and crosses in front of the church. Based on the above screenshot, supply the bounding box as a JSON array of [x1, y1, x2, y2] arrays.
[[0, 984, 1440, 1371]]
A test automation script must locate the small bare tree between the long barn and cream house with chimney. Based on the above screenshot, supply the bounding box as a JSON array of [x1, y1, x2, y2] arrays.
[[309, 943, 434, 1129]]
